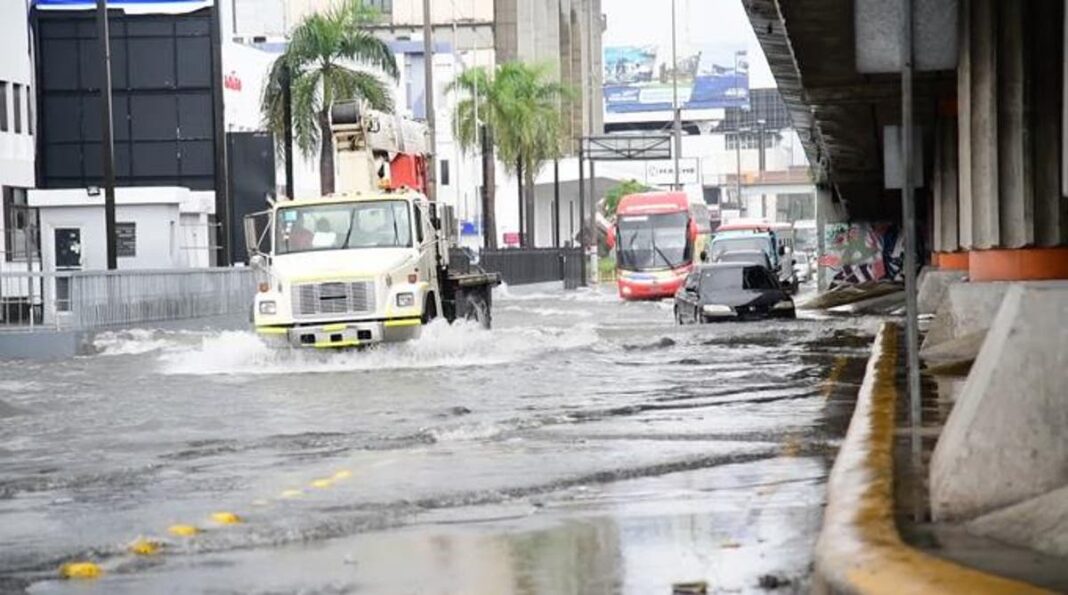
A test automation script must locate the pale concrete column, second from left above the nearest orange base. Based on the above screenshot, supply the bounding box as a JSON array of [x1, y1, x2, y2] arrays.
[[969, 0, 1001, 249]]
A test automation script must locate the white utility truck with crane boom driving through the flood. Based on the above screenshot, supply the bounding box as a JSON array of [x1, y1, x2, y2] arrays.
[[245, 99, 500, 348]]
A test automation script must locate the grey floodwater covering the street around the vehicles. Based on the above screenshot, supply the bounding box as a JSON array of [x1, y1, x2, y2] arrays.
[[0, 287, 878, 595]]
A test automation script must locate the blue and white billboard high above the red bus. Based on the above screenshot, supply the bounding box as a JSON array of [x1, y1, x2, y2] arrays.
[[604, 44, 749, 120]]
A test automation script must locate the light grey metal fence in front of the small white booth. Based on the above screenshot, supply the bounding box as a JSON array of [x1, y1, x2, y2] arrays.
[[0, 268, 256, 330]]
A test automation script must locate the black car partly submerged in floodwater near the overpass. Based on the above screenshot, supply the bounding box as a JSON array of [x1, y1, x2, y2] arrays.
[[675, 263, 797, 325]]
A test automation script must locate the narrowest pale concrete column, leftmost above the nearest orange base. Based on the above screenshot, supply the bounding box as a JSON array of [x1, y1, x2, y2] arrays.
[[957, 0, 972, 248]]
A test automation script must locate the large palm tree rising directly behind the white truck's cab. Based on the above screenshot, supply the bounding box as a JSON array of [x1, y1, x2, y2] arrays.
[[261, 0, 397, 194]]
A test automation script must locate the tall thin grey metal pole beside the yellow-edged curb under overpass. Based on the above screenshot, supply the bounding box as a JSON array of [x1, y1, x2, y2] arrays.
[[901, 0, 923, 464]]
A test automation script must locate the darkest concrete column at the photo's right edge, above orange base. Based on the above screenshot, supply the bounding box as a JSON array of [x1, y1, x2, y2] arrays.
[[1027, 0, 1068, 247]]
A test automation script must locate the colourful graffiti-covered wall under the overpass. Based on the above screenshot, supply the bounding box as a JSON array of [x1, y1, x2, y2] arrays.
[[819, 223, 905, 289]]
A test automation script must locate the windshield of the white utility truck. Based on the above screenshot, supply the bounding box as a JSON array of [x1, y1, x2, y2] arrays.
[[274, 201, 411, 254]]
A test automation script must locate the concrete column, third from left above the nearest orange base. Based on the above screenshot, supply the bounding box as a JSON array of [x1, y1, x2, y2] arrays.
[[995, 2, 1035, 248]]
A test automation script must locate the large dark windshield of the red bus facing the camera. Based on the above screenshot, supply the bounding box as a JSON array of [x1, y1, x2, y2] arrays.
[[616, 212, 691, 270]]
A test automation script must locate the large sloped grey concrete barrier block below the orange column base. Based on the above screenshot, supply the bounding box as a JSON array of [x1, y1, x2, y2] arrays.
[[930, 282, 1068, 520]]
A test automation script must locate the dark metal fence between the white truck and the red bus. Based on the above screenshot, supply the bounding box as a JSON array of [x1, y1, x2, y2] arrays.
[[478, 248, 582, 289]]
